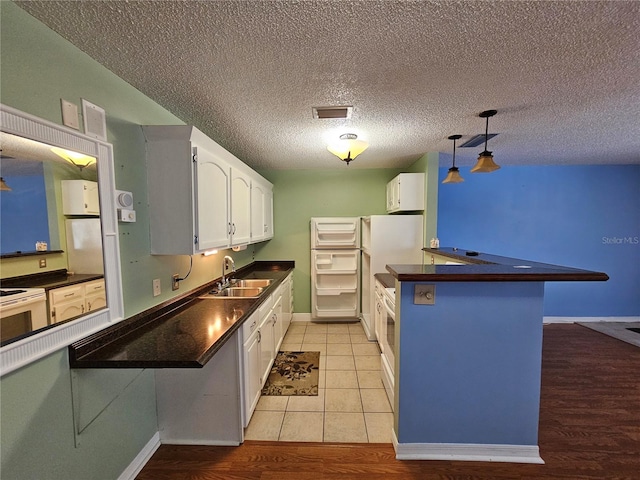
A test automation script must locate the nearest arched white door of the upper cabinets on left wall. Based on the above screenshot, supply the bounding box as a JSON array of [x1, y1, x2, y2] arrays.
[[193, 146, 231, 251]]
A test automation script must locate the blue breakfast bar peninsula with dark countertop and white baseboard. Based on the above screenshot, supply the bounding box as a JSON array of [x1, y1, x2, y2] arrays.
[[387, 248, 609, 463]]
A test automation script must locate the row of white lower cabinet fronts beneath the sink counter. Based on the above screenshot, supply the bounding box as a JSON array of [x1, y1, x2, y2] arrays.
[[241, 282, 290, 428]]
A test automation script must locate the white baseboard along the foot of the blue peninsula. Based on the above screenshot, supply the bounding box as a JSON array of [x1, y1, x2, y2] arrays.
[[393, 432, 544, 464]]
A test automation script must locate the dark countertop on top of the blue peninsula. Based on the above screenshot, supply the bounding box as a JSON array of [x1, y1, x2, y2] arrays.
[[387, 247, 609, 282]]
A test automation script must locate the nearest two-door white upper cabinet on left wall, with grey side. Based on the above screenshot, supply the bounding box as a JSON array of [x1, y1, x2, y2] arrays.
[[143, 126, 270, 255]]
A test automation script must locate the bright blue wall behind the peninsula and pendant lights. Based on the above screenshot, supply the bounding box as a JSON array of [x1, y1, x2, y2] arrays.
[[438, 165, 640, 317]]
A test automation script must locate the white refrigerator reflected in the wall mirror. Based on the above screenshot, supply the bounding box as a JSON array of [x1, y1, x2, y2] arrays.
[[65, 218, 104, 274]]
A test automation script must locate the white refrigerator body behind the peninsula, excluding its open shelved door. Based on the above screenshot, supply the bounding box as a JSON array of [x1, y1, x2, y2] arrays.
[[361, 215, 424, 341]]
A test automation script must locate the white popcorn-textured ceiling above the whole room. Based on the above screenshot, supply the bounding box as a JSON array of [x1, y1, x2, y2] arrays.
[[16, 0, 640, 168]]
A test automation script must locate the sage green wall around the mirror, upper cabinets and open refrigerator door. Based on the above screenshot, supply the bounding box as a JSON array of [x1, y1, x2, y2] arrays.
[[0, 1, 436, 480]]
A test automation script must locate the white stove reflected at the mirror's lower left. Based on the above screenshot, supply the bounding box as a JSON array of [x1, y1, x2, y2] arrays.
[[0, 288, 47, 343]]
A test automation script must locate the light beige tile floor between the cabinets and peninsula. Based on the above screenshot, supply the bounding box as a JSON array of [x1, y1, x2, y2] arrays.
[[245, 322, 393, 443]]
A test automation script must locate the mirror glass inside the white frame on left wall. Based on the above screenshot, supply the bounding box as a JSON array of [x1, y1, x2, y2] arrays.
[[0, 132, 107, 345]]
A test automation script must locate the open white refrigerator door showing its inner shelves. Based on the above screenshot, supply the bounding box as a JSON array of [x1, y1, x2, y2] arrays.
[[311, 217, 360, 321]]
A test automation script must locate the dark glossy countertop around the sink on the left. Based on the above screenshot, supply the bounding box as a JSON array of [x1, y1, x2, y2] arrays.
[[69, 262, 294, 368]]
